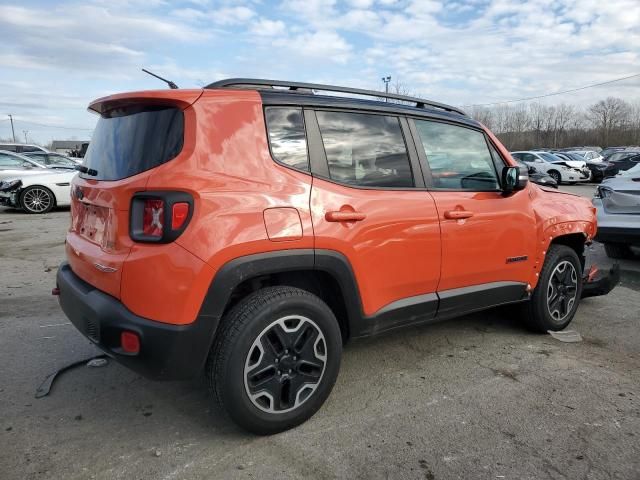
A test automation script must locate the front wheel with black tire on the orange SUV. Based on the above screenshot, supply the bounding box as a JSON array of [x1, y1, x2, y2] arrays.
[[524, 245, 582, 332]]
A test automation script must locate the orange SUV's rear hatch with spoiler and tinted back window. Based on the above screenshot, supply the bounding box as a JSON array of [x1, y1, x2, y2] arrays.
[[67, 90, 201, 298]]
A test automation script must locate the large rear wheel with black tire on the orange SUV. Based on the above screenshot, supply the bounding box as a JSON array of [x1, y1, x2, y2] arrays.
[[206, 287, 342, 435]]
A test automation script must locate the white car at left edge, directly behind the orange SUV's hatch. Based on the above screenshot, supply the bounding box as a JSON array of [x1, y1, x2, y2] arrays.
[[0, 170, 78, 213]]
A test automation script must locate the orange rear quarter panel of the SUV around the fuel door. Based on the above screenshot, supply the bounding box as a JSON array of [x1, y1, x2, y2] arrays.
[[122, 90, 314, 323]]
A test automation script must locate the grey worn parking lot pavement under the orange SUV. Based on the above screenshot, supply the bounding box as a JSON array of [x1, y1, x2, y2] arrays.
[[0, 202, 640, 480]]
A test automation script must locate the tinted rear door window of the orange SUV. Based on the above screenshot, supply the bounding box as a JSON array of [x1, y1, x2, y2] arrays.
[[316, 112, 414, 188]]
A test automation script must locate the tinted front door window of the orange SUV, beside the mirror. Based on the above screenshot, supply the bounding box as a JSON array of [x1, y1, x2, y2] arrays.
[[415, 120, 500, 191]]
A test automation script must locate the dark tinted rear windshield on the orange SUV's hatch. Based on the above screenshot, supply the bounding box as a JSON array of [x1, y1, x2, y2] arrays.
[[81, 105, 184, 180]]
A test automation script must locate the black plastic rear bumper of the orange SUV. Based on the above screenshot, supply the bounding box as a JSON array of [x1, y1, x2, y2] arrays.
[[56, 262, 218, 380]]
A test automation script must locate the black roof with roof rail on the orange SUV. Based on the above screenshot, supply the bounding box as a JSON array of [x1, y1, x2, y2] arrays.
[[205, 78, 479, 126]]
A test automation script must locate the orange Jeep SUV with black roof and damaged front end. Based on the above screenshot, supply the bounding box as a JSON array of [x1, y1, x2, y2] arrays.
[[56, 79, 616, 434]]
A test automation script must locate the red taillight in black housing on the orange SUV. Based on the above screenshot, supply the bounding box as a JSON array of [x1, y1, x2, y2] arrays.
[[129, 191, 193, 243]]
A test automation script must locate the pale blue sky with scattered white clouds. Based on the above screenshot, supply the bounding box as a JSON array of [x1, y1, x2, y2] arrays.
[[0, 0, 640, 144]]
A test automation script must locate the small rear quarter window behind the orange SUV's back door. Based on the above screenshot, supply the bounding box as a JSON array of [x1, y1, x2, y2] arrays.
[[265, 107, 309, 171]]
